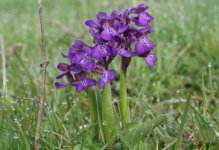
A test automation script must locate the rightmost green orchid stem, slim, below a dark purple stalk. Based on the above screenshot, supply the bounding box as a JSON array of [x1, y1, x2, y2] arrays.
[[119, 70, 130, 128]]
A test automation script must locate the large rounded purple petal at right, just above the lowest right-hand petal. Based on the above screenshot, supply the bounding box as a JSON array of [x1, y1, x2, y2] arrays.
[[135, 37, 154, 55]]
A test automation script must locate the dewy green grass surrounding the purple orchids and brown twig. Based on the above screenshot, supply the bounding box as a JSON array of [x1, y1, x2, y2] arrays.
[[0, 0, 219, 150]]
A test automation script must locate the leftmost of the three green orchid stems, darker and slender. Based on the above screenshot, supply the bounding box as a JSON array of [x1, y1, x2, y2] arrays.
[[87, 88, 99, 142]]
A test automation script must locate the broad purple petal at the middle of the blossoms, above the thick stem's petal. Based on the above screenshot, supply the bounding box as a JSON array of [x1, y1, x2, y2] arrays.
[[91, 44, 111, 60]]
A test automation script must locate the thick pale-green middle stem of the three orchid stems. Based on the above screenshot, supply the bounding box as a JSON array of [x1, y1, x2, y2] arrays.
[[102, 84, 115, 144]]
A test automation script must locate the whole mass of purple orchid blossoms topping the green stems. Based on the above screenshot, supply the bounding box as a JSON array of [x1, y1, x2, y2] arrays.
[[55, 4, 157, 92]]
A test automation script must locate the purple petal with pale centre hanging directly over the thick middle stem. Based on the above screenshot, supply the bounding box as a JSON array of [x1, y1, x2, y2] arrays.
[[98, 69, 116, 90]]
